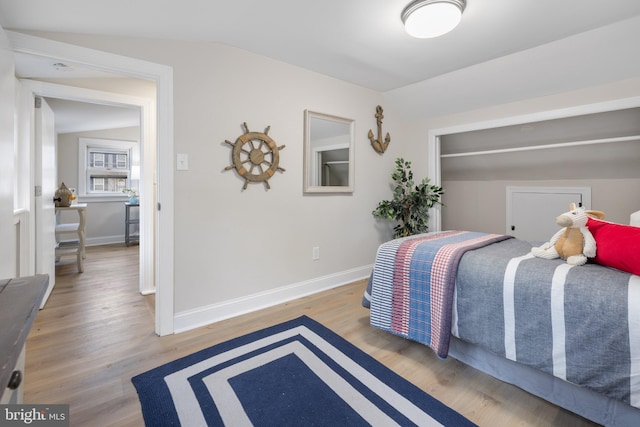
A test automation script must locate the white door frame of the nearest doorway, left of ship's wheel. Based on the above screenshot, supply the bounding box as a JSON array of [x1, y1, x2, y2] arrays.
[[6, 31, 174, 336]]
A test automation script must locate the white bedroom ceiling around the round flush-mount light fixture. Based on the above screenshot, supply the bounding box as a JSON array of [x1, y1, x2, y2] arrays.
[[0, 0, 640, 131]]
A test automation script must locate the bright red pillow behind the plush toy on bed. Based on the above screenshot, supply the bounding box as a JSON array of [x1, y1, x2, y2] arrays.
[[587, 217, 640, 276]]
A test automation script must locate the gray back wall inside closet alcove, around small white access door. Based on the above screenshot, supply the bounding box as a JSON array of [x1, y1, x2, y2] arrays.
[[441, 108, 640, 233]]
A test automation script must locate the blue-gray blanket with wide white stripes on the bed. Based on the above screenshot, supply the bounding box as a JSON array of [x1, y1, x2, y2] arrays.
[[452, 239, 640, 410]]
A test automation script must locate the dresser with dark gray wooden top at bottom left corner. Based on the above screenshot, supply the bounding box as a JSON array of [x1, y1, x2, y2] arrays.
[[0, 275, 49, 404]]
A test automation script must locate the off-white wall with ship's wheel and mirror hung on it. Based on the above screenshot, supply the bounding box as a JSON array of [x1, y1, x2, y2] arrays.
[[25, 35, 403, 315]]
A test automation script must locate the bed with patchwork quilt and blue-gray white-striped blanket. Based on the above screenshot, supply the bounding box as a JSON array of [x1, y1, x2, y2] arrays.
[[363, 231, 640, 426]]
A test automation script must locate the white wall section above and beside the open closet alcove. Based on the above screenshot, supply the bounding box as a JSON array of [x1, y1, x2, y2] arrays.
[[383, 17, 640, 191]]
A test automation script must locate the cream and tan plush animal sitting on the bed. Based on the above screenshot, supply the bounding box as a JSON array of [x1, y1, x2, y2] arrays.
[[531, 203, 604, 265]]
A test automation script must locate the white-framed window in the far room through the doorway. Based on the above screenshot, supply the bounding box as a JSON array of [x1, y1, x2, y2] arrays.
[[78, 138, 139, 197]]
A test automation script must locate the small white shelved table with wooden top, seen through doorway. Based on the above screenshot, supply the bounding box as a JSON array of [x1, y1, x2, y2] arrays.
[[56, 203, 87, 273]]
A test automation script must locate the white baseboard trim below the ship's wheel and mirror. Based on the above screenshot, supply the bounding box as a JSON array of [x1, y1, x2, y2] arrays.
[[173, 265, 372, 333]]
